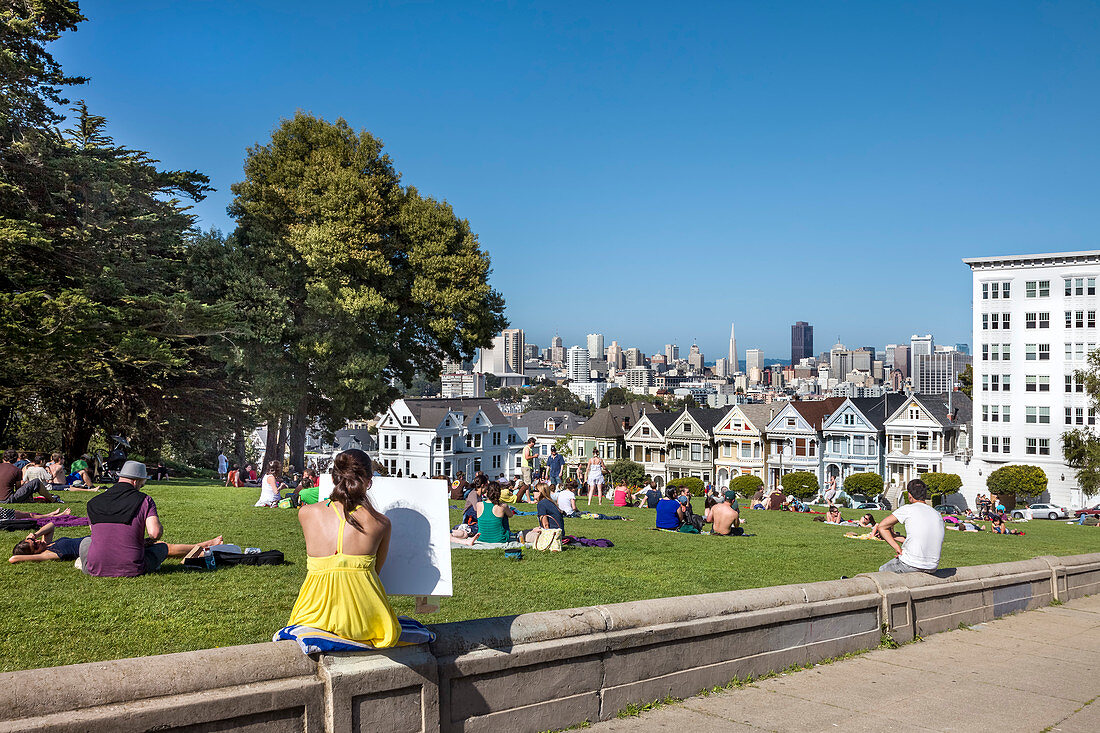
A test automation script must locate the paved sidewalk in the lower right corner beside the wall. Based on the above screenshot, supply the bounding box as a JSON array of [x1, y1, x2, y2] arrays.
[[587, 595, 1100, 733]]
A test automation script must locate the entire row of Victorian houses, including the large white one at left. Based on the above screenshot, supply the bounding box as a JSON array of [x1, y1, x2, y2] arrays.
[[377, 392, 971, 501]]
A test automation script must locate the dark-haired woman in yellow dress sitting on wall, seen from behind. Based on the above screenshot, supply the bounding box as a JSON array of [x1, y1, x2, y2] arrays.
[[289, 449, 402, 648]]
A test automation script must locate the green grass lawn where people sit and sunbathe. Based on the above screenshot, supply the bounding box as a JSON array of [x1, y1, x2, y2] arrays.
[[0, 481, 1100, 671]]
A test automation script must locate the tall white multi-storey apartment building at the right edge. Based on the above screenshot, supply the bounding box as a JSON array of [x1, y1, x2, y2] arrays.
[[963, 250, 1100, 507]]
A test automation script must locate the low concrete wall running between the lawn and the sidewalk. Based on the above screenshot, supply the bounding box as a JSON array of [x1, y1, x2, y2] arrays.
[[0, 554, 1100, 733]]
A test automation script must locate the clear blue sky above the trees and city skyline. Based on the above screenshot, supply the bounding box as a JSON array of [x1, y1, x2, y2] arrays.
[[54, 0, 1100, 361]]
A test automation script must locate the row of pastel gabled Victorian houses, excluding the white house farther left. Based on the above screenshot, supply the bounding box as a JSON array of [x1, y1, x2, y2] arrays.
[[569, 392, 971, 499]]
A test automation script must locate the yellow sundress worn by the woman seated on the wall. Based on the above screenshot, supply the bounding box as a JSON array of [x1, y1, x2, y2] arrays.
[[289, 502, 402, 648]]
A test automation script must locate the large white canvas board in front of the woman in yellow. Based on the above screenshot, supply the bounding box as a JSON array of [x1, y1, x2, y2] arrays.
[[318, 473, 453, 595]]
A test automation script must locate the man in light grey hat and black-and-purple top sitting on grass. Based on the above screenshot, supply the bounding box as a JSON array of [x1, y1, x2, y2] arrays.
[[80, 461, 168, 578]]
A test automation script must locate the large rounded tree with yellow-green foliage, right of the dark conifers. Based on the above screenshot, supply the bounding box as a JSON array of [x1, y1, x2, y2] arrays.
[[230, 112, 506, 464]]
